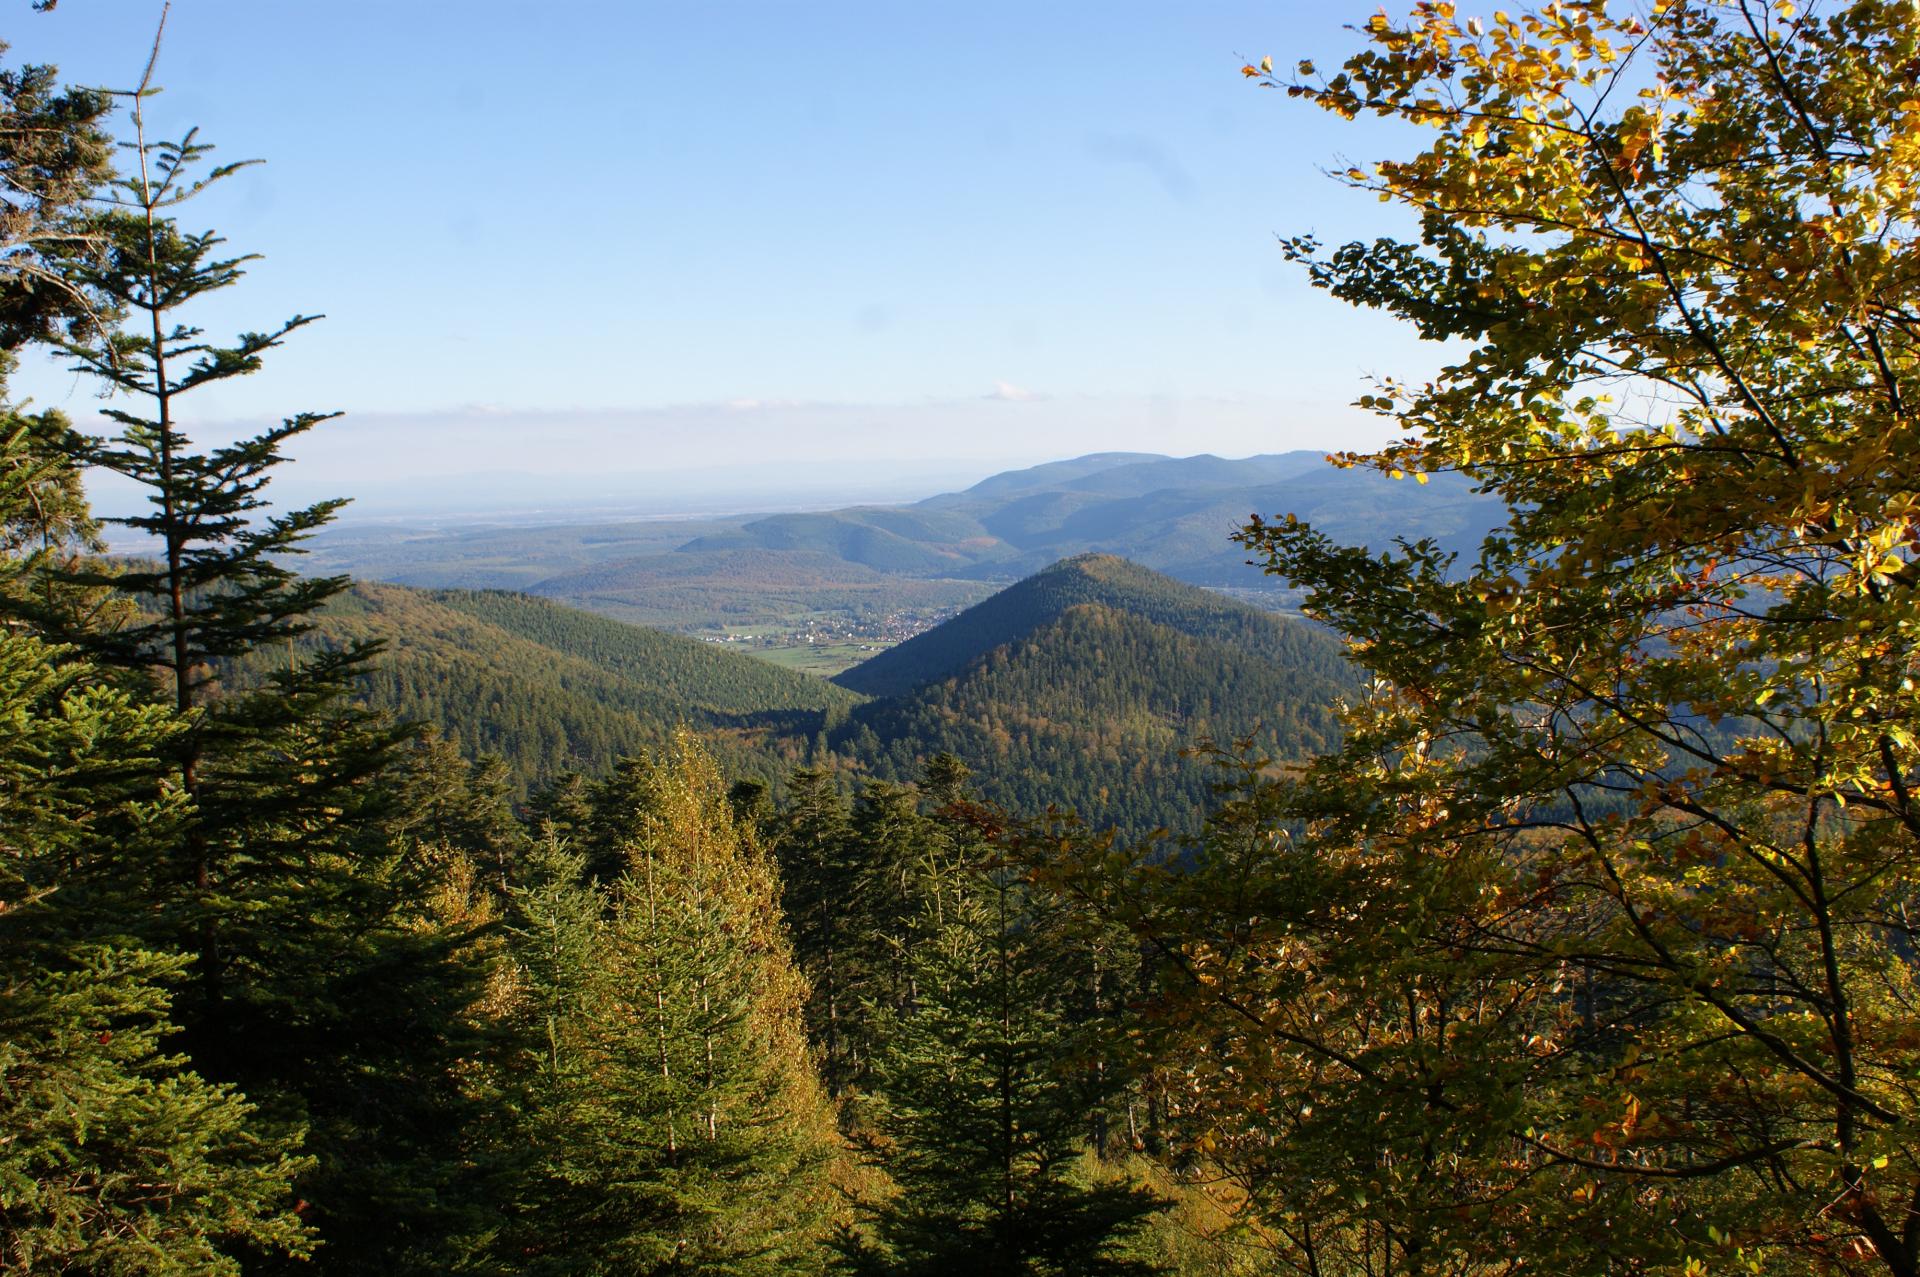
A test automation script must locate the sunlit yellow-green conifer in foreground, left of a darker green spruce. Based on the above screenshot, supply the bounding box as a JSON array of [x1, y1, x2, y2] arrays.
[[509, 734, 833, 1275]]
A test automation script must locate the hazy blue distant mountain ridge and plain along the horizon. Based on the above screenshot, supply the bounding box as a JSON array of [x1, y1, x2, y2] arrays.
[[309, 451, 1505, 632]]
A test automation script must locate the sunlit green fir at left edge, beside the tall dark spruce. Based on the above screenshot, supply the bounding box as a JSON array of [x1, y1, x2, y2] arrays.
[[0, 416, 309, 1273]]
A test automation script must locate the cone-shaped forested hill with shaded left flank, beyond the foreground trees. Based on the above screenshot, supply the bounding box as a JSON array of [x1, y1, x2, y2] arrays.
[[829, 555, 1356, 831]]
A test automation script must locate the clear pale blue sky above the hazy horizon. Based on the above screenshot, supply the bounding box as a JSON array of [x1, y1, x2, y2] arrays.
[[4, 0, 1438, 511]]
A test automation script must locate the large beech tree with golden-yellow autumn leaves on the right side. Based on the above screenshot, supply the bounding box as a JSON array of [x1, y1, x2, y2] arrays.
[[1059, 0, 1920, 1275]]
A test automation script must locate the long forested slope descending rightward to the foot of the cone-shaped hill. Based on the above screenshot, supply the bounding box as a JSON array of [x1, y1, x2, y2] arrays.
[[264, 584, 856, 793]]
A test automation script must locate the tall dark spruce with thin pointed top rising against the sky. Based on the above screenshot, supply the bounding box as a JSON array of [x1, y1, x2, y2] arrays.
[[35, 47, 503, 1273]]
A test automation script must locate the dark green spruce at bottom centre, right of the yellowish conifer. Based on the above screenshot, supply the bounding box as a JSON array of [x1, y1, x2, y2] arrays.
[[841, 833, 1164, 1277]]
